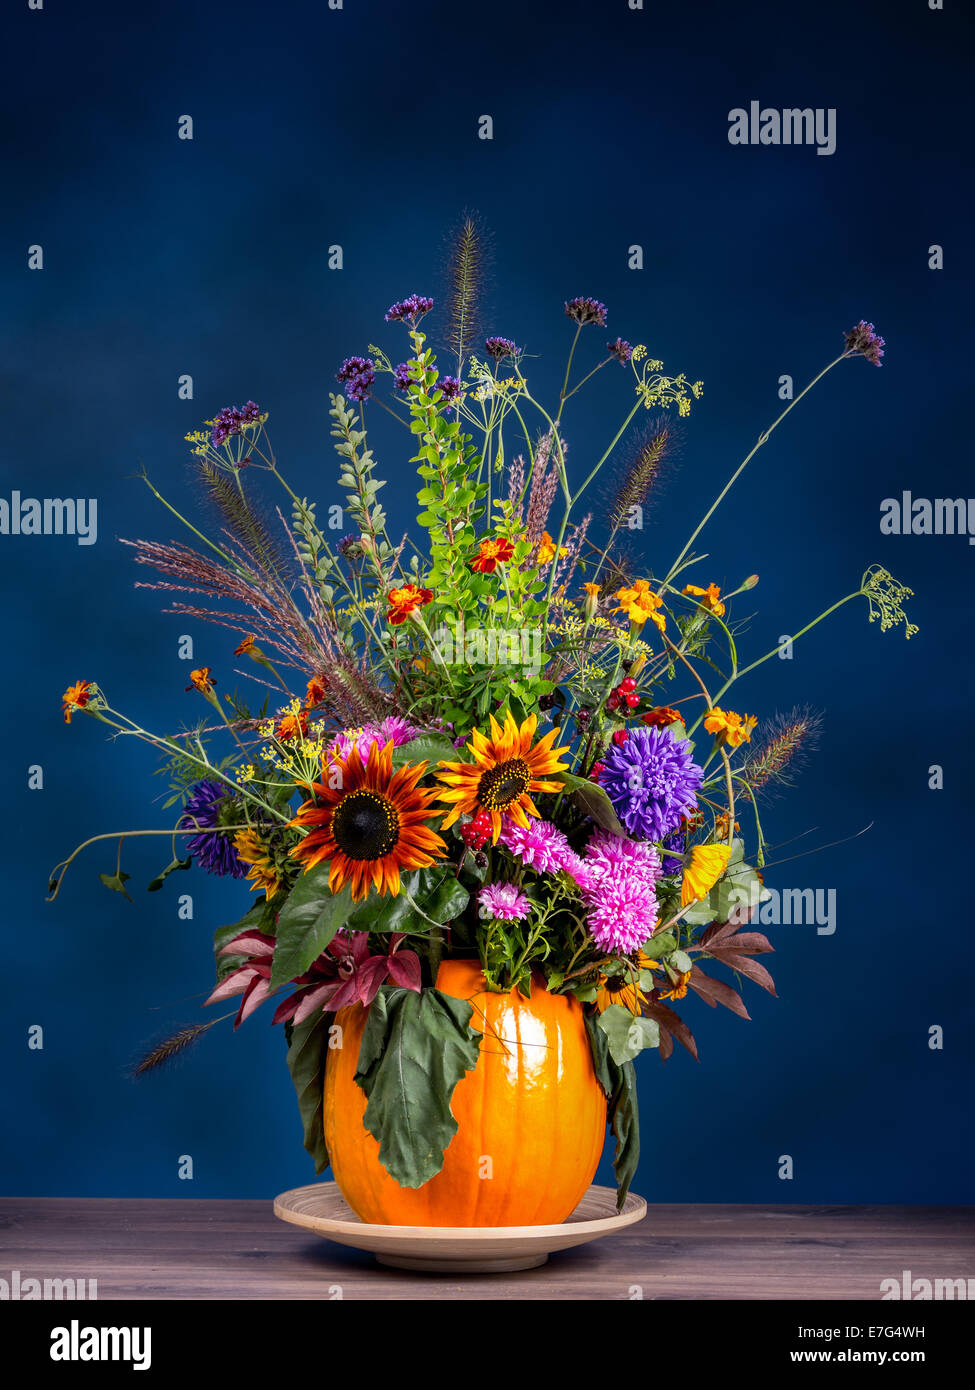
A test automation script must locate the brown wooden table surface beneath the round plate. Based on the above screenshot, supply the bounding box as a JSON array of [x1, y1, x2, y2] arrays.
[[0, 1197, 975, 1300]]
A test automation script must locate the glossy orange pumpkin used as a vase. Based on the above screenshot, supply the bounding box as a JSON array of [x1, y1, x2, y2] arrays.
[[324, 960, 606, 1226]]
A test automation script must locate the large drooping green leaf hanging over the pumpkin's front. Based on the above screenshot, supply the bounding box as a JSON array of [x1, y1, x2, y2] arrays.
[[356, 988, 481, 1187]]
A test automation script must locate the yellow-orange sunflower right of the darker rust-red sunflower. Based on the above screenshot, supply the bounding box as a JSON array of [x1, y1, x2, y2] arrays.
[[437, 710, 569, 845]]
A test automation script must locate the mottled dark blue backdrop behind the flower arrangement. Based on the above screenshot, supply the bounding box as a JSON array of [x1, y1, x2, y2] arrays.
[[0, 0, 975, 1202]]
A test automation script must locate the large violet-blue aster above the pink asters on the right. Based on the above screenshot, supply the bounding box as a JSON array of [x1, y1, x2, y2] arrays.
[[599, 728, 704, 840]]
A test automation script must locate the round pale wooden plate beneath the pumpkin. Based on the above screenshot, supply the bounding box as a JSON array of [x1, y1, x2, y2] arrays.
[[274, 1183, 647, 1275]]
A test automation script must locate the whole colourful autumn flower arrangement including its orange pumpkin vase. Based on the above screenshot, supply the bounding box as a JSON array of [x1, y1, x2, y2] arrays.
[[51, 233, 915, 1226]]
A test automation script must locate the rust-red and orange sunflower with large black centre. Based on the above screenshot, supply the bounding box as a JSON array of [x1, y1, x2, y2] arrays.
[[291, 739, 446, 901]]
